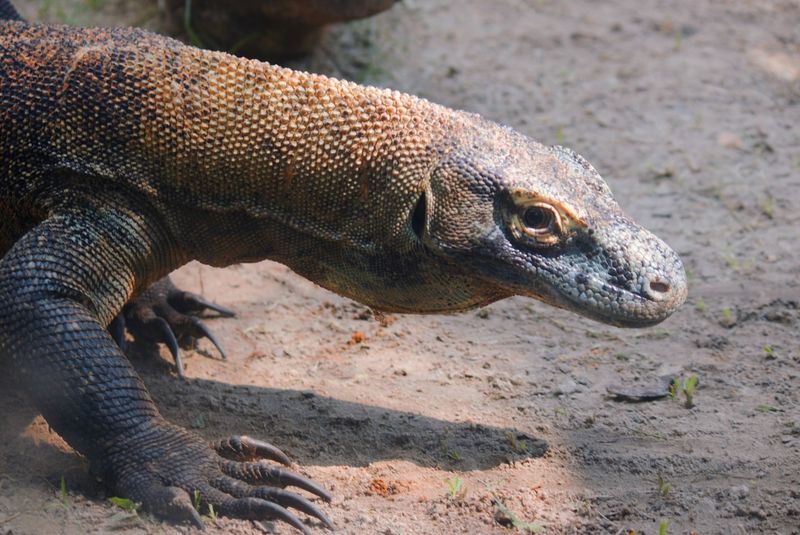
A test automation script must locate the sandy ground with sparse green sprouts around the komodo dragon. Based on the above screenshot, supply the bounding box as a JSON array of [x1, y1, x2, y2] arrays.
[[0, 0, 800, 535]]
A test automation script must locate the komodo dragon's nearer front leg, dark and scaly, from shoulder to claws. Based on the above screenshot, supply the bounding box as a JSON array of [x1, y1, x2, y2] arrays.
[[0, 199, 332, 532]]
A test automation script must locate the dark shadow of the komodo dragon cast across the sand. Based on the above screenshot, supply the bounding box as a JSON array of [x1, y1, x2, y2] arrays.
[[0, 359, 548, 496]]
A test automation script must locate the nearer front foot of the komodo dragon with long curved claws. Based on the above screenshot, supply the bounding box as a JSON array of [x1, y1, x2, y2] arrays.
[[109, 426, 335, 535]]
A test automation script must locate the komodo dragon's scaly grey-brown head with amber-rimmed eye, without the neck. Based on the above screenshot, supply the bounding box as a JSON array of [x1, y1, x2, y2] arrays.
[[390, 115, 687, 327]]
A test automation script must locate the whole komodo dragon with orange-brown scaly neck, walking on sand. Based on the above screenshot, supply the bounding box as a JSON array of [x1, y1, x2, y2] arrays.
[[0, 0, 686, 532]]
